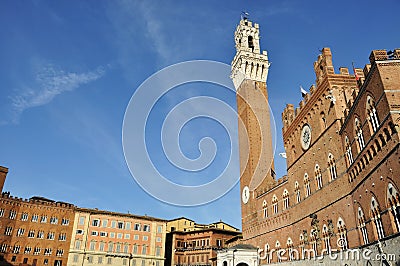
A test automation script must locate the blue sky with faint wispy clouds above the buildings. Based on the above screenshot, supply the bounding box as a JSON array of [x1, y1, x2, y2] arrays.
[[0, 0, 400, 227]]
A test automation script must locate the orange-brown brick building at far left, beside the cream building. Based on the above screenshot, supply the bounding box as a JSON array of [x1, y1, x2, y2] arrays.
[[0, 193, 74, 266]]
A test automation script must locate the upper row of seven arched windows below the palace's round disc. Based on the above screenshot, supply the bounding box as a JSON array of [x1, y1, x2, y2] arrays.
[[263, 153, 338, 218]]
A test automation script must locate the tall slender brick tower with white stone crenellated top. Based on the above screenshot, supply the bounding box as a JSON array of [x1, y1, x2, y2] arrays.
[[231, 18, 275, 235]]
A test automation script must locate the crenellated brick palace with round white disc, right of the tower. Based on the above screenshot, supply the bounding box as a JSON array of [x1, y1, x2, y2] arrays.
[[235, 18, 400, 264]]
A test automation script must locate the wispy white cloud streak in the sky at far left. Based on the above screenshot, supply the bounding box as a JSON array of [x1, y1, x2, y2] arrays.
[[9, 65, 105, 124]]
